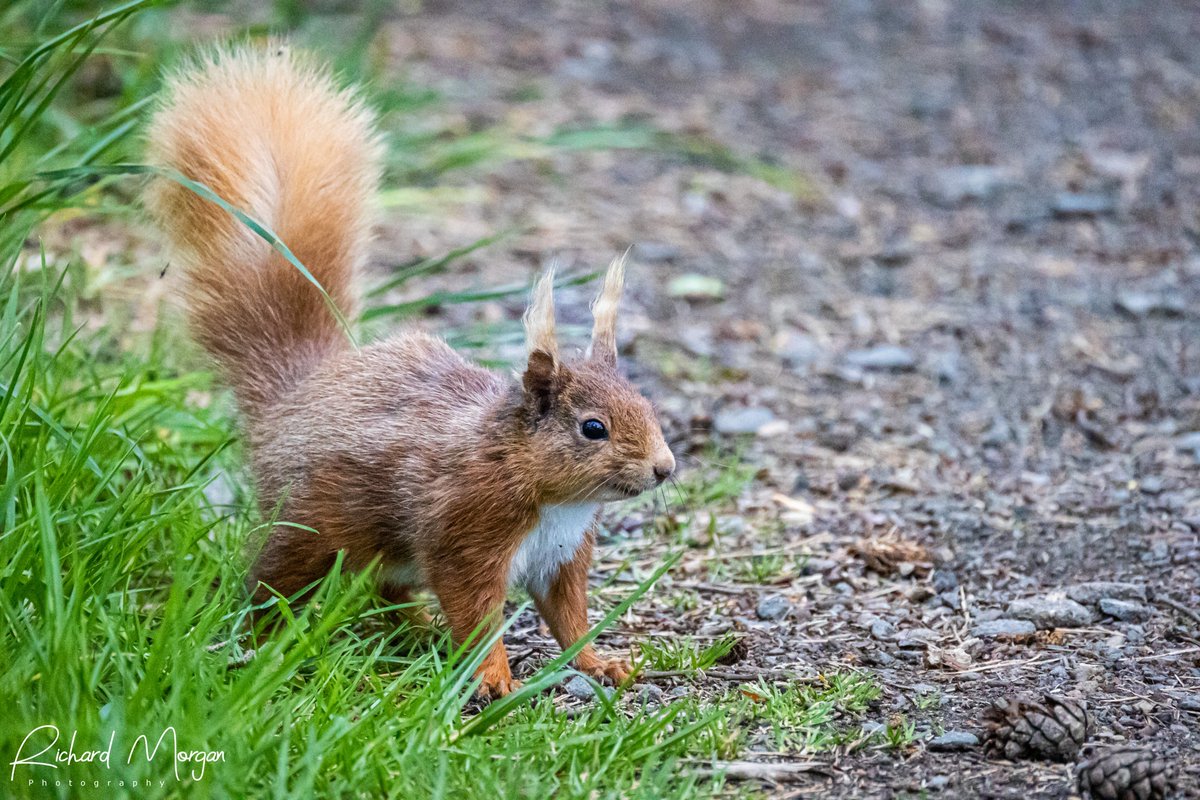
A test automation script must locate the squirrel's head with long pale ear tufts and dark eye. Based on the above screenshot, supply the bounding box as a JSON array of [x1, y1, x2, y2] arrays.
[[522, 258, 674, 503]]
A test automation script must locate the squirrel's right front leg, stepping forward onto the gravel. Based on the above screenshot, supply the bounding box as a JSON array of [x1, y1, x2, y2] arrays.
[[529, 531, 630, 684]]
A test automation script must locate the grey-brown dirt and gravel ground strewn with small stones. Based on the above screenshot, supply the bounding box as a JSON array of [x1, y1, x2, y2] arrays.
[[312, 0, 1200, 798]]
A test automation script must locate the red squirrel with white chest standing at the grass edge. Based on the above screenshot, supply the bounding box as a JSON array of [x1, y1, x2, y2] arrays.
[[145, 47, 676, 697]]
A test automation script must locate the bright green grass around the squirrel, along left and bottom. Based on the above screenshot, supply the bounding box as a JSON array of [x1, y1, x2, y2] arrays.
[[0, 0, 844, 799]]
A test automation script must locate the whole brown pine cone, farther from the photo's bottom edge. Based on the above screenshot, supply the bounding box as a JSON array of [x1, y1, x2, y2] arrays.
[[983, 694, 1091, 762]]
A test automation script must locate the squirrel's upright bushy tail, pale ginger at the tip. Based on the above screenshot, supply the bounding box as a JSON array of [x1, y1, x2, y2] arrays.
[[146, 47, 382, 415]]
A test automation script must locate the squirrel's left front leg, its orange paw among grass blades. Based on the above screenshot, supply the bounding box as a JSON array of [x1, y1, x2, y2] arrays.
[[428, 554, 521, 699]]
